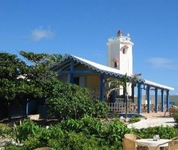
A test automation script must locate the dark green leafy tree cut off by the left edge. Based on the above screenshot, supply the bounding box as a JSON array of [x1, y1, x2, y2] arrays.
[[0, 53, 25, 119]]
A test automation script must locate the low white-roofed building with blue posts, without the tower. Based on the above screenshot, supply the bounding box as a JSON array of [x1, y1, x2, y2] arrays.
[[51, 54, 174, 114]]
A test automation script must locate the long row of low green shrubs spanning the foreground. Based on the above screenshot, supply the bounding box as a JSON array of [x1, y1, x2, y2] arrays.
[[6, 115, 130, 150]]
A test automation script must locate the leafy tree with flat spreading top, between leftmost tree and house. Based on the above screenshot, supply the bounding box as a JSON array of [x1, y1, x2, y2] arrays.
[[16, 51, 62, 116]]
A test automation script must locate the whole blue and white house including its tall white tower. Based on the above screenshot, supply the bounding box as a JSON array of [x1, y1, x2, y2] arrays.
[[53, 30, 174, 114]]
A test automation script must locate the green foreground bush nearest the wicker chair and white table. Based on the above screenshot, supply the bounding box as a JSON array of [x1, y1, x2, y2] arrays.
[[60, 115, 130, 150]]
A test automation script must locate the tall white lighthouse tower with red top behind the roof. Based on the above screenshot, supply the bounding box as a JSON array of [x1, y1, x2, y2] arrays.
[[107, 30, 134, 95]]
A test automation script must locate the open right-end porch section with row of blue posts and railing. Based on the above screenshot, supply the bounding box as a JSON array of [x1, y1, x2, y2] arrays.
[[109, 80, 174, 114]]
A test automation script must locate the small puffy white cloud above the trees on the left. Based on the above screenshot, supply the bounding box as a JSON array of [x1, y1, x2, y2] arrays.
[[29, 28, 54, 42]]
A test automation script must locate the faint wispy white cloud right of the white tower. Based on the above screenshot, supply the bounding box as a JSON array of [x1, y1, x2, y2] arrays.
[[147, 57, 178, 70]]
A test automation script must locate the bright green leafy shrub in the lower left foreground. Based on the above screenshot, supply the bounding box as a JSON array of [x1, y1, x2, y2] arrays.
[[11, 119, 65, 150]]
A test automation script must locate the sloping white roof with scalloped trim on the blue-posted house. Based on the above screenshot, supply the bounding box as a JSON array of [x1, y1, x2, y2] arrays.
[[52, 54, 174, 90]]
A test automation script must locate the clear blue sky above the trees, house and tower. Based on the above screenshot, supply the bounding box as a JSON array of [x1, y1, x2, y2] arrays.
[[0, 0, 178, 94]]
